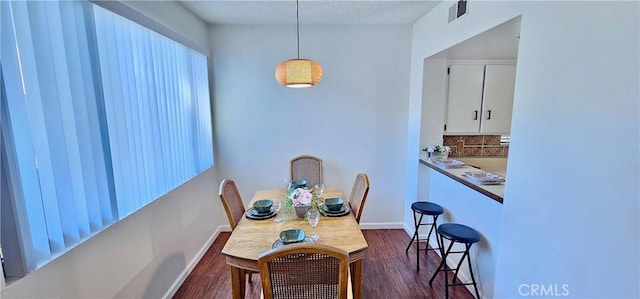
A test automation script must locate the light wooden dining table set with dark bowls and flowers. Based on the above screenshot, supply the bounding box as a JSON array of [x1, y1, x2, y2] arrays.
[[222, 188, 368, 299]]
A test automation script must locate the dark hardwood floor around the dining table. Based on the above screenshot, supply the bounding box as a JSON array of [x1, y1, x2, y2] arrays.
[[173, 229, 473, 299]]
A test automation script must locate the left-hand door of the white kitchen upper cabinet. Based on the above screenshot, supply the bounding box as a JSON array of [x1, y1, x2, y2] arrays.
[[446, 65, 484, 133]]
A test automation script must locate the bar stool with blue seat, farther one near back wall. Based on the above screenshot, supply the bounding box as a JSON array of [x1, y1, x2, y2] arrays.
[[405, 201, 444, 271]]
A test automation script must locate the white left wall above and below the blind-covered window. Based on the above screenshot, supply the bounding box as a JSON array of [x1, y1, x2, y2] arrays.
[[0, 2, 227, 298]]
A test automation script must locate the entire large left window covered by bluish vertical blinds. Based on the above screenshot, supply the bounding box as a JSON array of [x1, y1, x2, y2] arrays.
[[0, 1, 213, 277]]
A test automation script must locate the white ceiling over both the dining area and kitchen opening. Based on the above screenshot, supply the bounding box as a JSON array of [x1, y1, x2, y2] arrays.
[[179, 0, 520, 59]]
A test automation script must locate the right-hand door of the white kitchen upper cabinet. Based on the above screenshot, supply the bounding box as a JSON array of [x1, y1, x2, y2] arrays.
[[480, 65, 516, 134]]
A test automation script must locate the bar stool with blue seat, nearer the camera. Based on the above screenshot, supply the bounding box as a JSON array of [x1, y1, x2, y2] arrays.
[[429, 223, 480, 298]]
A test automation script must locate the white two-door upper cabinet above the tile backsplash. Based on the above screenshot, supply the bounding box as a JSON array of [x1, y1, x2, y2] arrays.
[[445, 64, 515, 134]]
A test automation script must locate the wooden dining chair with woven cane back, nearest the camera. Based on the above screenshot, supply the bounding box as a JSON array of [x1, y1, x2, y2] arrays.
[[258, 243, 353, 299]]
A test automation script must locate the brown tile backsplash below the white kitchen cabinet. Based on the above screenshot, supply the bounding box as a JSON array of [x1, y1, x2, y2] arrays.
[[444, 135, 509, 157]]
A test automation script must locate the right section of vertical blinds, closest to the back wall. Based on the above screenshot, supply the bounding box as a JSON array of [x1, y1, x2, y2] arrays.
[[94, 7, 213, 216]]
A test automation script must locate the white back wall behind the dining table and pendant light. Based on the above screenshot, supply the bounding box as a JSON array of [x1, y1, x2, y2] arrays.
[[210, 25, 411, 227]]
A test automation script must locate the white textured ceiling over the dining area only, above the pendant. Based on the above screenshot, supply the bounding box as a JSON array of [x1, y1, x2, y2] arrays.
[[178, 0, 442, 25]]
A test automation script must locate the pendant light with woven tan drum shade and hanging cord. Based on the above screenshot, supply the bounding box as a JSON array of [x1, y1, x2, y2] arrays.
[[276, 0, 322, 88]]
